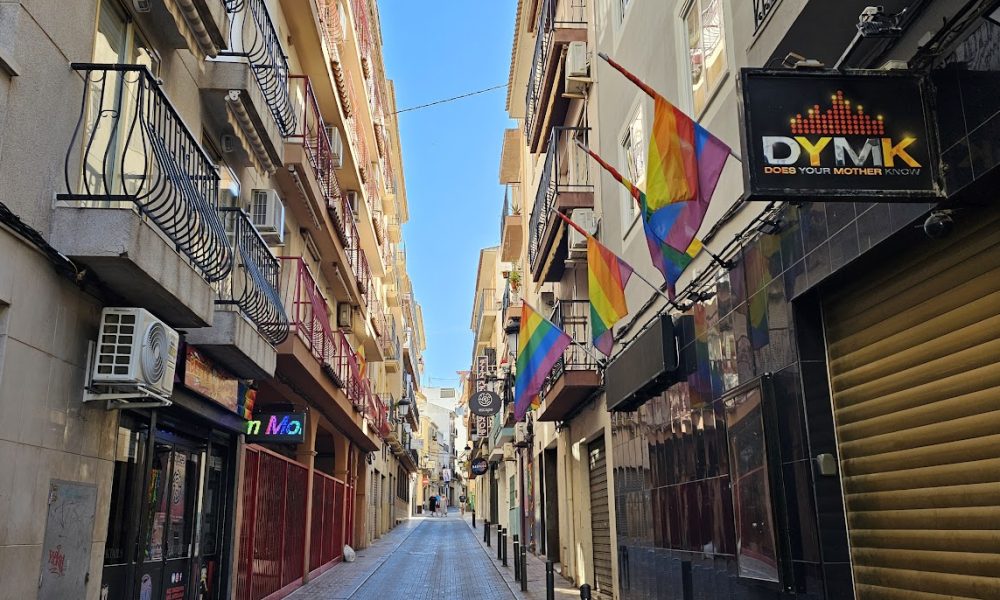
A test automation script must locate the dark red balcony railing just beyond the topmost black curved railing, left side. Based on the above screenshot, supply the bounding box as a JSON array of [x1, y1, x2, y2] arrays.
[[288, 75, 341, 207]]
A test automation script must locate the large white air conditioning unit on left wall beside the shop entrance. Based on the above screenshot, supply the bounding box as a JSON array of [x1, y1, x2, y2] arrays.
[[88, 308, 180, 400]]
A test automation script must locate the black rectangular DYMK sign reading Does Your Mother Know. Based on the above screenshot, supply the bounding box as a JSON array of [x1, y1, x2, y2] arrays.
[[740, 69, 942, 202]]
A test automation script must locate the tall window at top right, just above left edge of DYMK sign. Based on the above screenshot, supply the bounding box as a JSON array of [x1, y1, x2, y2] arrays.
[[684, 0, 729, 116]]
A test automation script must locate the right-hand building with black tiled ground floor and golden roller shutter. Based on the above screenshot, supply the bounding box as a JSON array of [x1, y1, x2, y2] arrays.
[[498, 0, 1000, 599]]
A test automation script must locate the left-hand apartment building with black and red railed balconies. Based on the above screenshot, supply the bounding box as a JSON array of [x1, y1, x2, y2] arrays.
[[0, 0, 425, 599]]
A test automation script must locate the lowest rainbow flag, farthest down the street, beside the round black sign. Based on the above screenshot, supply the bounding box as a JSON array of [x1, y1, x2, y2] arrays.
[[514, 302, 573, 421]]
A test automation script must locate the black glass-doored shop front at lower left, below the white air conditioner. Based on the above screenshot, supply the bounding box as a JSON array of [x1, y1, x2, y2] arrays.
[[101, 347, 253, 600]]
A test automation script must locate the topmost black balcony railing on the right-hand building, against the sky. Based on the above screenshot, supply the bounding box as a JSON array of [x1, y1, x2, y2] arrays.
[[524, 0, 587, 139]]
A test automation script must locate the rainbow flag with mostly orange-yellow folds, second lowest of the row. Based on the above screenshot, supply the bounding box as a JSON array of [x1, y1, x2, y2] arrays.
[[587, 235, 632, 356]]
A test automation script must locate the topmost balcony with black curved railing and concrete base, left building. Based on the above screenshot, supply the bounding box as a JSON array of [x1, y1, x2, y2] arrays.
[[199, 0, 295, 173]]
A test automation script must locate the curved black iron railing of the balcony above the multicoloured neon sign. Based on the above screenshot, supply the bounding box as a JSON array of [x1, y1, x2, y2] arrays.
[[217, 207, 289, 345]]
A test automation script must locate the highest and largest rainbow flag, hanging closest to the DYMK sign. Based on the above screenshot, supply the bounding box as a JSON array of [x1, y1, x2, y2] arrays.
[[643, 95, 731, 253]]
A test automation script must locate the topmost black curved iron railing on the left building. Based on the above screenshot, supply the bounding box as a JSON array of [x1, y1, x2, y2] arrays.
[[219, 0, 295, 137]]
